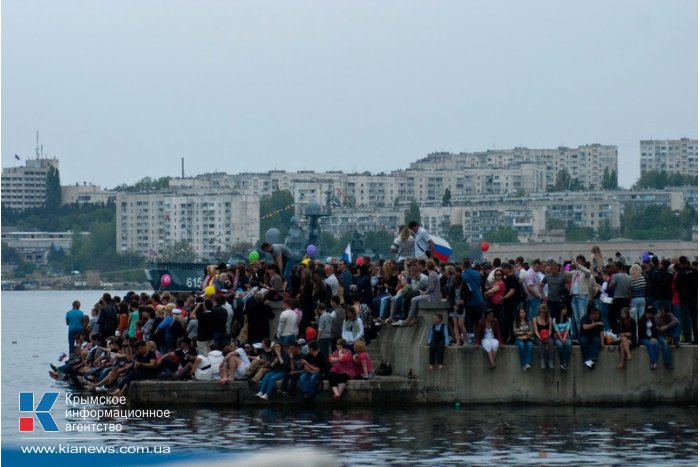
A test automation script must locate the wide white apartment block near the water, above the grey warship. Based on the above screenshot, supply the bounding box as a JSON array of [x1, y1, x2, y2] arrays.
[[116, 190, 260, 259]]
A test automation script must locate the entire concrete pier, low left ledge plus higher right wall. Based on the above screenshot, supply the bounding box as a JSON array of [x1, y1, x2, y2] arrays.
[[129, 302, 698, 406]]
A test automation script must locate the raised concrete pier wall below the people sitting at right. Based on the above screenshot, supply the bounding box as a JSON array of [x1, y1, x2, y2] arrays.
[[379, 302, 698, 404]]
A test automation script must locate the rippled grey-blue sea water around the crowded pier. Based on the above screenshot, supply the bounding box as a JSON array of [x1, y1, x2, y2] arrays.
[[1, 291, 698, 466]]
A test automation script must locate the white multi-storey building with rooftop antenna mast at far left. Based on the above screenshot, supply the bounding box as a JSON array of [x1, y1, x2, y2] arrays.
[[2, 157, 58, 210]]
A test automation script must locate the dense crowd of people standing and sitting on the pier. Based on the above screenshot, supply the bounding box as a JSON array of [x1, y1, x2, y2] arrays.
[[50, 222, 697, 400]]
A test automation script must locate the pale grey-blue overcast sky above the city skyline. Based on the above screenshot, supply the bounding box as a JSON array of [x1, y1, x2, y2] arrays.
[[2, 0, 698, 188]]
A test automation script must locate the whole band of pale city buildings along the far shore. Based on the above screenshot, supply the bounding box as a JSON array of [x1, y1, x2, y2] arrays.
[[2, 138, 698, 257]]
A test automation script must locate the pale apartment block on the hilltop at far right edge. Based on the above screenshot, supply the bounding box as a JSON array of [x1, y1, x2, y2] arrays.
[[639, 138, 698, 177]]
